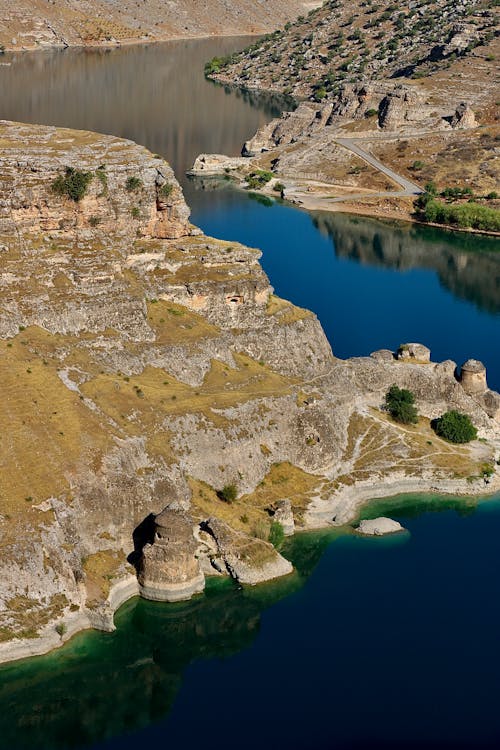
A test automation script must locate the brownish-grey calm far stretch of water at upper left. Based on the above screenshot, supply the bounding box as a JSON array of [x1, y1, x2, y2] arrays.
[[0, 37, 290, 180]]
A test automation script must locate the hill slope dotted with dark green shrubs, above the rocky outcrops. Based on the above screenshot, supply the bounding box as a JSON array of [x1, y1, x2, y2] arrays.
[[209, 0, 499, 102]]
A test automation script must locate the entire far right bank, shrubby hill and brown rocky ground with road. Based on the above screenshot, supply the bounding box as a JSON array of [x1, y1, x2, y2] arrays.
[[207, 0, 500, 228]]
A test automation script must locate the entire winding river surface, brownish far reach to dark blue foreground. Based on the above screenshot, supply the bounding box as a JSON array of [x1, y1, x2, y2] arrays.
[[0, 39, 500, 750]]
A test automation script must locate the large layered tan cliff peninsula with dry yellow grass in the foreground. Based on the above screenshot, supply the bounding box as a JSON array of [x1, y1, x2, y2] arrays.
[[0, 122, 500, 660]]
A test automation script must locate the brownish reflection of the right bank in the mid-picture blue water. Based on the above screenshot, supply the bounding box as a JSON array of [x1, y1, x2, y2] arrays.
[[312, 212, 500, 313]]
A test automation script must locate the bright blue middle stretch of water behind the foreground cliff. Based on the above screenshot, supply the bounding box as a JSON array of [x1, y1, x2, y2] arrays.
[[189, 192, 500, 389]]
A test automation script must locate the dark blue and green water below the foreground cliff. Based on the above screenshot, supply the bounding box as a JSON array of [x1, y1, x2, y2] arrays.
[[0, 496, 500, 750]]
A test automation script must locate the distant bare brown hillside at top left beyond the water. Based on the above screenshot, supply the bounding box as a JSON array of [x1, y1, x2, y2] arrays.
[[0, 0, 319, 50]]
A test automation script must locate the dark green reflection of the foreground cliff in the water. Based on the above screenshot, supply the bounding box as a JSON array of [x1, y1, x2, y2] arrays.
[[0, 532, 332, 750]]
